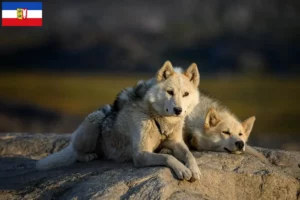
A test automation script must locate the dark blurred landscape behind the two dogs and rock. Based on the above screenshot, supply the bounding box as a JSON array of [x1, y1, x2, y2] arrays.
[[0, 0, 300, 150]]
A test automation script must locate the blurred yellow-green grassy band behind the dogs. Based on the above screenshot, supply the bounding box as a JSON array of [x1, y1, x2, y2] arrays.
[[0, 73, 300, 134]]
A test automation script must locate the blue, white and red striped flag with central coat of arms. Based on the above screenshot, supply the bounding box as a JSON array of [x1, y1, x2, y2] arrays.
[[2, 2, 43, 26]]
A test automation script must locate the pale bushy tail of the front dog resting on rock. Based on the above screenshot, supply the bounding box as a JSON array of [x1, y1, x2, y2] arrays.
[[36, 144, 77, 170]]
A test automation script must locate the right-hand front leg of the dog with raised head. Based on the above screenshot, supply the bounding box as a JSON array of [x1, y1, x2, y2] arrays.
[[163, 140, 201, 180]]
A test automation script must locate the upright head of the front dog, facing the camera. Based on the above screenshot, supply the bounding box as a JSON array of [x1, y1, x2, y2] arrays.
[[147, 61, 200, 117]]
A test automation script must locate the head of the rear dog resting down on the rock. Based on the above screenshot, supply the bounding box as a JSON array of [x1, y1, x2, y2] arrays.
[[204, 108, 255, 153]]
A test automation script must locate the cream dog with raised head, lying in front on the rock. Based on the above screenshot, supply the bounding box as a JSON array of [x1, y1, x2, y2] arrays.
[[37, 61, 200, 180]]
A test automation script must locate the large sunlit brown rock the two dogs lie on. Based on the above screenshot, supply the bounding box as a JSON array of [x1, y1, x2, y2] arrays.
[[0, 134, 300, 200]]
